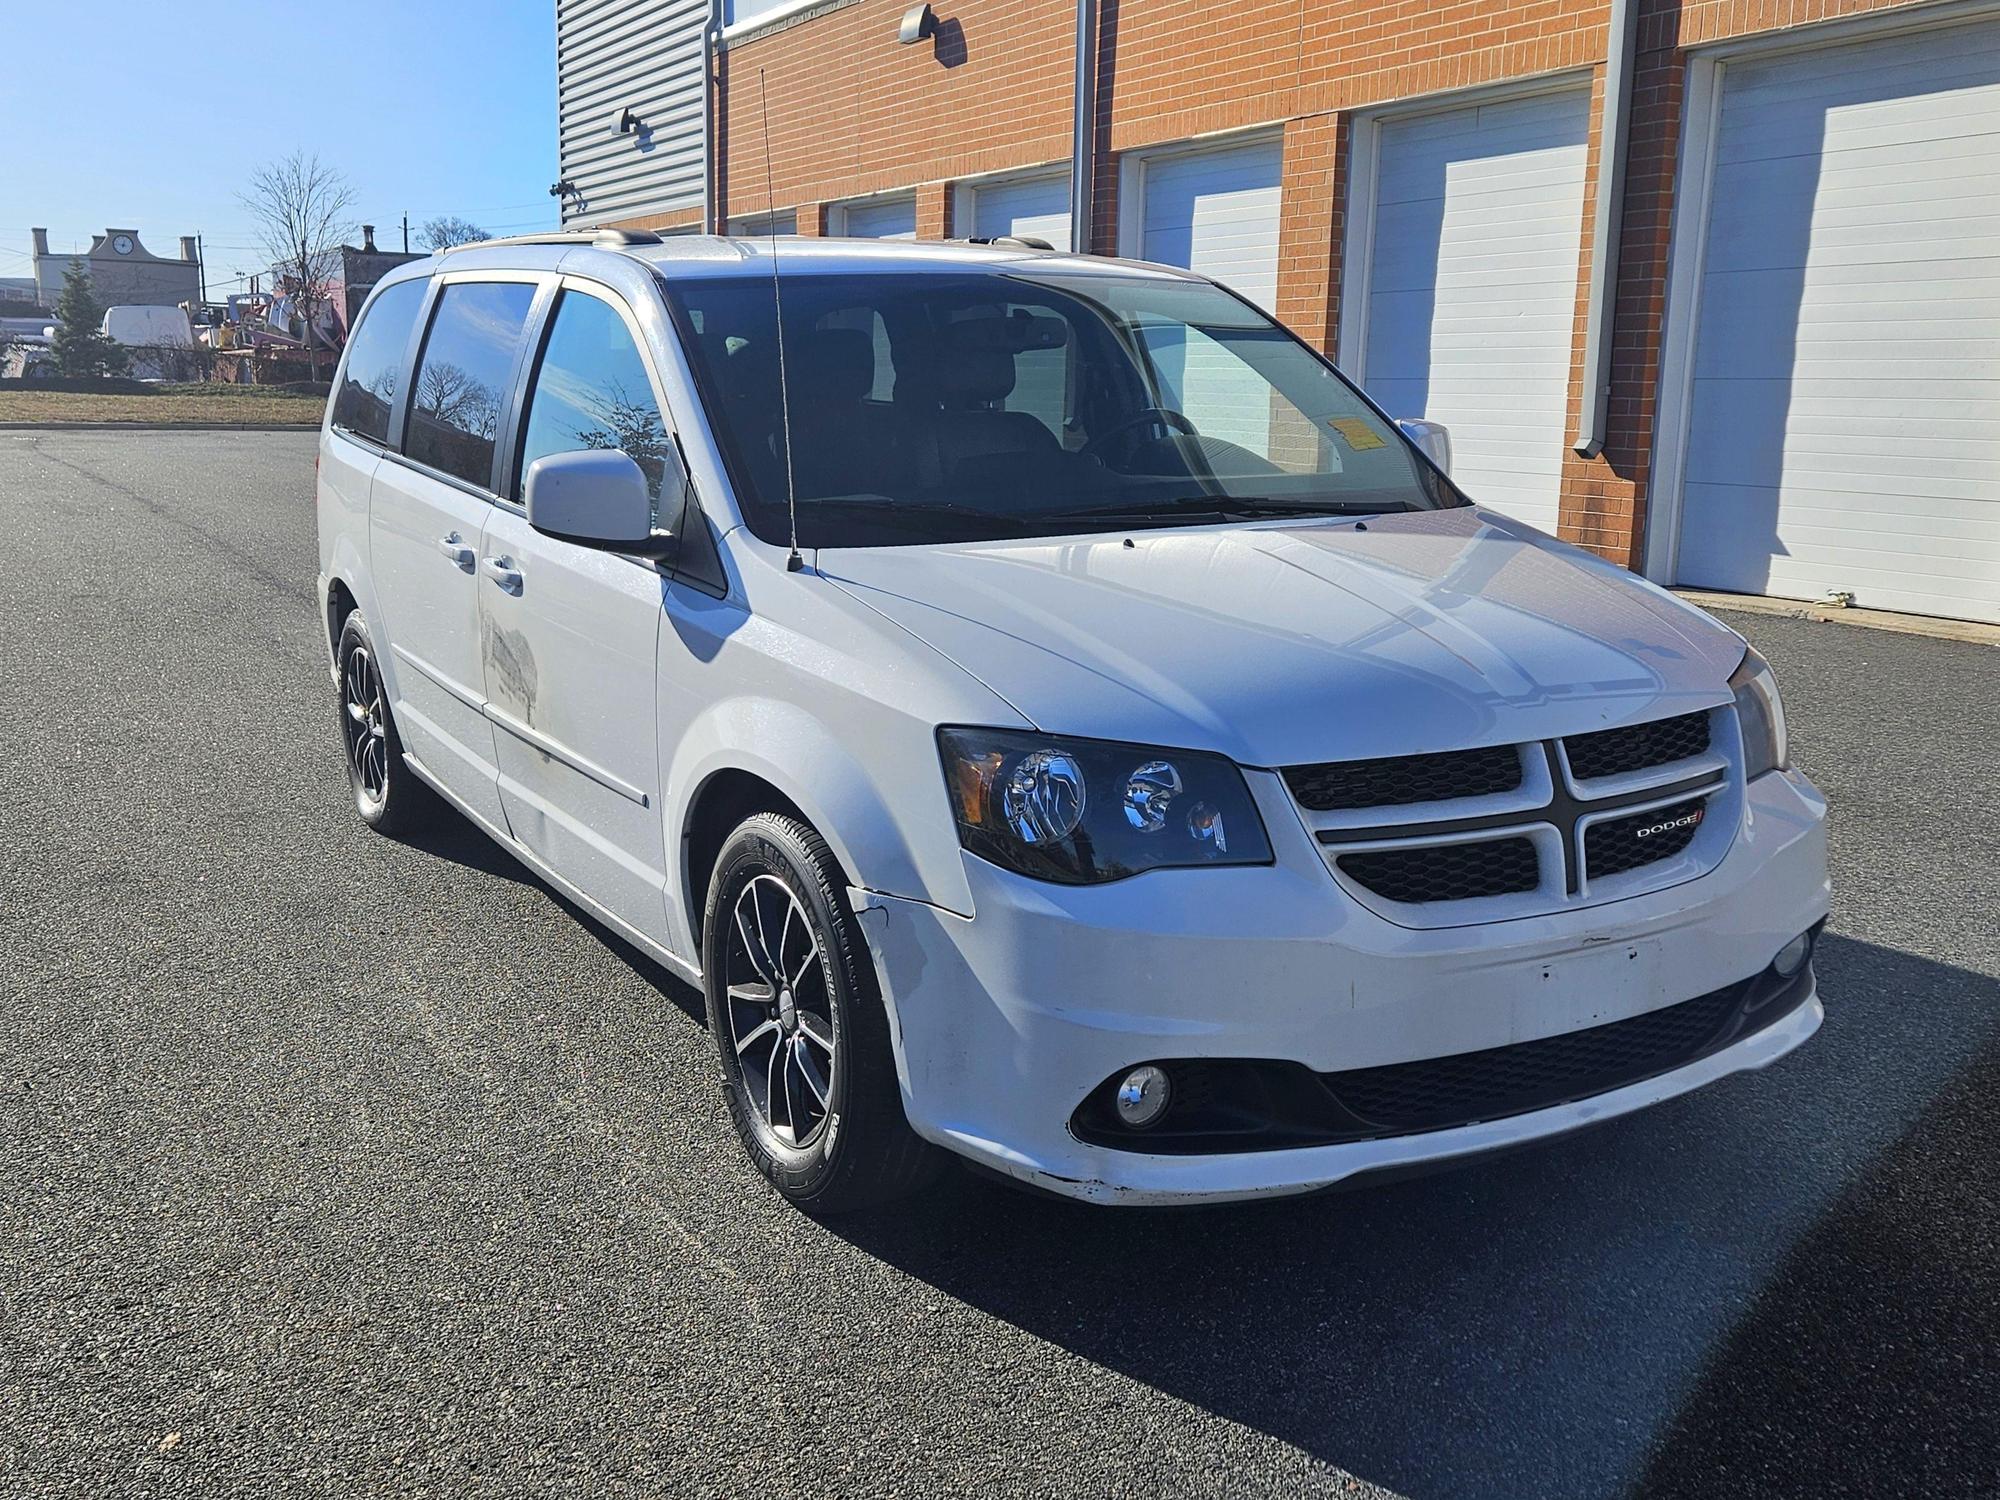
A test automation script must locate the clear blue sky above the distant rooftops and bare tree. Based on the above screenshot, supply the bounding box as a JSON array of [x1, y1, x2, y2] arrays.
[[0, 0, 556, 296]]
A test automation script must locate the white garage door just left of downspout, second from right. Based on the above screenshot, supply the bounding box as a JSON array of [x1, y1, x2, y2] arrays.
[[1356, 90, 1590, 532]]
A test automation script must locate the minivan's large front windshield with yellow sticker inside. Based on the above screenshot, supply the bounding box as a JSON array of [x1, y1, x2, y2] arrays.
[[666, 272, 1464, 546]]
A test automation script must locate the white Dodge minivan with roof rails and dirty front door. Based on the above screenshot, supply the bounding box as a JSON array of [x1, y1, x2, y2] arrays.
[[318, 232, 1828, 1212]]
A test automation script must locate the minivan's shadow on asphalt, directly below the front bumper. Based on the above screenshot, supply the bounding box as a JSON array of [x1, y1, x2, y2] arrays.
[[830, 936, 2000, 1496]]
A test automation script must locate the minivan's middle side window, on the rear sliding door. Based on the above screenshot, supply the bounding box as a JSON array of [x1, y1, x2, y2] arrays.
[[404, 282, 534, 486]]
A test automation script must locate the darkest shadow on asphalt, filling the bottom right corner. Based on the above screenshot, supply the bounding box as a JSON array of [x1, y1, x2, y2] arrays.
[[1640, 1042, 2000, 1500]]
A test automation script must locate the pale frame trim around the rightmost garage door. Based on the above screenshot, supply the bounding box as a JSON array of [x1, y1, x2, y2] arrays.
[[1640, 0, 2000, 586]]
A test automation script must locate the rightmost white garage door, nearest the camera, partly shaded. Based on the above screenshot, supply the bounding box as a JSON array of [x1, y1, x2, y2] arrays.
[[1678, 22, 2000, 620]]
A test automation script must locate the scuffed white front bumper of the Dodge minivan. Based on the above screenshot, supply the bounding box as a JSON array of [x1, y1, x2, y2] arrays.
[[852, 772, 1830, 1204]]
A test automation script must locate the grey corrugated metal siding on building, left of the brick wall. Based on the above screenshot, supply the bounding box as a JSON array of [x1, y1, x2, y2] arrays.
[[556, 0, 708, 222]]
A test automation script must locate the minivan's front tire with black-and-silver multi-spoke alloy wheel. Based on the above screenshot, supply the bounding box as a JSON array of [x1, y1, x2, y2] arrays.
[[702, 812, 942, 1214]]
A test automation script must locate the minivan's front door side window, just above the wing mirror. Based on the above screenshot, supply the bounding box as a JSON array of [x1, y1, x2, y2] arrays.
[[520, 292, 680, 526]]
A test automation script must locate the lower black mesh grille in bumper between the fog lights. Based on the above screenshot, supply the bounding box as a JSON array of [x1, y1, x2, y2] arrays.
[[1320, 984, 1744, 1134]]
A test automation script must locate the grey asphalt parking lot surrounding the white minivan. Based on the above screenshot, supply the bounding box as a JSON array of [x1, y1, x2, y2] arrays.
[[0, 432, 2000, 1496]]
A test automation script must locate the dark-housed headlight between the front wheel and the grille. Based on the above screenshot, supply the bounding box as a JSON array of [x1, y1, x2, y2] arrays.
[[938, 730, 1270, 886]]
